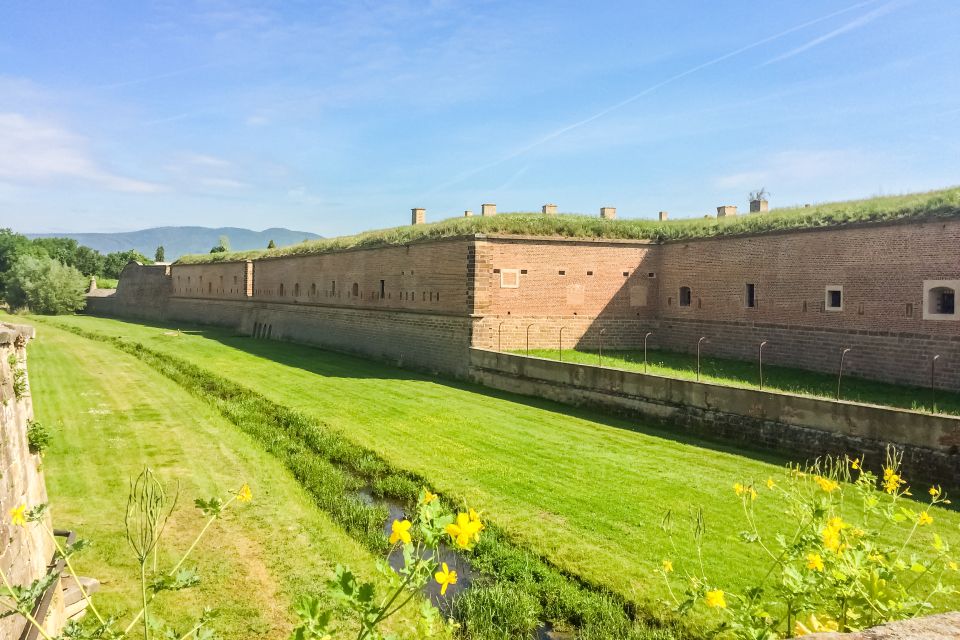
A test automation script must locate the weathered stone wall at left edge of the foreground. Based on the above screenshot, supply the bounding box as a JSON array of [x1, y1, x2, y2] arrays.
[[0, 323, 63, 639]]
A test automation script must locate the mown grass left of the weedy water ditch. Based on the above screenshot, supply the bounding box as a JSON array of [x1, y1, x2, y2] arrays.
[[27, 319, 424, 639]]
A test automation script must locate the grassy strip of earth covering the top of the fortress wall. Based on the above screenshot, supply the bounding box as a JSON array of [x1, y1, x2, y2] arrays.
[[178, 187, 960, 263]]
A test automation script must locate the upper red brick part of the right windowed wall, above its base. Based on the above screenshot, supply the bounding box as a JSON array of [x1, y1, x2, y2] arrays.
[[659, 220, 960, 336]]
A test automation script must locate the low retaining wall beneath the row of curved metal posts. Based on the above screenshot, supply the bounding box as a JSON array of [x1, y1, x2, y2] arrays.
[[470, 349, 960, 488]]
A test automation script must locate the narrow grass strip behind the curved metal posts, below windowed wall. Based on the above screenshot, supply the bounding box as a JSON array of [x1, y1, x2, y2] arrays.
[[514, 349, 960, 414]]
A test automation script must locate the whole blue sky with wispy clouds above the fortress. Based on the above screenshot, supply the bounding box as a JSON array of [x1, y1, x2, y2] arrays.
[[0, 0, 960, 236]]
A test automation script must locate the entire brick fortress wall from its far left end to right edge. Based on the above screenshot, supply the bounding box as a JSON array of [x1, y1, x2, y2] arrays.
[[88, 220, 960, 389]]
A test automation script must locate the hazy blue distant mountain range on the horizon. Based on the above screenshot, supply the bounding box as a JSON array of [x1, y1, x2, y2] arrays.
[[25, 227, 322, 261]]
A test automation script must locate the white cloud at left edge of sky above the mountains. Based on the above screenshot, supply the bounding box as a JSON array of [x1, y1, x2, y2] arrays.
[[0, 113, 162, 193]]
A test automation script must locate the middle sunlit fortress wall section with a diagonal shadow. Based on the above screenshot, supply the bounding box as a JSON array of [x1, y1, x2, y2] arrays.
[[472, 236, 659, 350]]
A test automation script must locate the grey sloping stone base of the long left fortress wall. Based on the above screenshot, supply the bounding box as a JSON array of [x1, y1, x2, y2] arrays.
[[166, 298, 470, 375]]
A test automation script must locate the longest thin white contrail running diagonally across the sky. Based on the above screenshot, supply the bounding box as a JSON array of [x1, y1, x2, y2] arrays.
[[421, 0, 880, 197]]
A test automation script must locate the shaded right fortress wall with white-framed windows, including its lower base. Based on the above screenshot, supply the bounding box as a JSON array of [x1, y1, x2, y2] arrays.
[[651, 220, 960, 389]]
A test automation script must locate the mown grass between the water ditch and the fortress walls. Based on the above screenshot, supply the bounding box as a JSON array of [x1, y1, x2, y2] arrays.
[[33, 317, 960, 606]]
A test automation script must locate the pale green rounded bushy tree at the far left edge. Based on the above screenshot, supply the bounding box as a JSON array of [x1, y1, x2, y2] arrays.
[[4, 255, 87, 315]]
